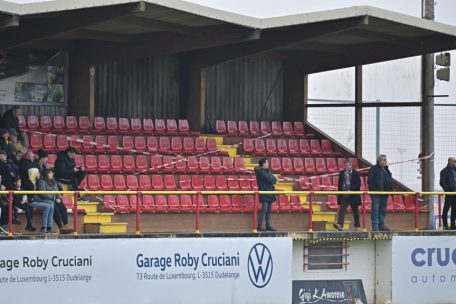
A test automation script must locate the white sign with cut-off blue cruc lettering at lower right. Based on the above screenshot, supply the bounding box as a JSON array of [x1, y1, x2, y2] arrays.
[[392, 236, 456, 304]]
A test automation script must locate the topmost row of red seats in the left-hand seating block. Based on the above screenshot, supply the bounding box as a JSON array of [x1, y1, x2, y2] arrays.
[[19, 115, 192, 135]]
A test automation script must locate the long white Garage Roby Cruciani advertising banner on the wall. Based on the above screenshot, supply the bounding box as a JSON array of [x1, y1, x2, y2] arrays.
[[0, 238, 292, 304]]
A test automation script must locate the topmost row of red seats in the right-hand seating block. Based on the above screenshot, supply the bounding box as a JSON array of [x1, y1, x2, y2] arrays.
[[215, 120, 310, 137]]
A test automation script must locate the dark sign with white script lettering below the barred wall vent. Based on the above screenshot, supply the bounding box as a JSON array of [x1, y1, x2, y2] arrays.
[[293, 280, 367, 304]]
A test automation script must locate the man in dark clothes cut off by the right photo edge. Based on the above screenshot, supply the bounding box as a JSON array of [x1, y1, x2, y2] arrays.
[[440, 157, 456, 230]]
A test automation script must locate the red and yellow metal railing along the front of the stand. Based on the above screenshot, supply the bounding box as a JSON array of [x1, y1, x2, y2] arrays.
[[0, 191, 456, 237]]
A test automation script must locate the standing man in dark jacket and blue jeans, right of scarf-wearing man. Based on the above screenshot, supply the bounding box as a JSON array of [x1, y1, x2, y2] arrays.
[[367, 154, 393, 231]]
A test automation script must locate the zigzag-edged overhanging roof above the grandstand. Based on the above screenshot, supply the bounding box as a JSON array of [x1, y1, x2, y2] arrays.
[[0, 0, 456, 72]]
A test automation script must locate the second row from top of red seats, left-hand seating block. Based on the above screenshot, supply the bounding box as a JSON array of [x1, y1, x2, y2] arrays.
[[29, 134, 219, 155]]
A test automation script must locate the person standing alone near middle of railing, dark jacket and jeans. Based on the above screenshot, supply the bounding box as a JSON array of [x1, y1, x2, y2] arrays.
[[255, 158, 277, 231]]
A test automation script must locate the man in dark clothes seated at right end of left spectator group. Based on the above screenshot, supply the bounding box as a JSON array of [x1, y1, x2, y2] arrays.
[[55, 148, 86, 191]]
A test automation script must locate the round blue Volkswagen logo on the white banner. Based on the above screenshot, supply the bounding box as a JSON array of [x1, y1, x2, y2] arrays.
[[247, 243, 272, 288]]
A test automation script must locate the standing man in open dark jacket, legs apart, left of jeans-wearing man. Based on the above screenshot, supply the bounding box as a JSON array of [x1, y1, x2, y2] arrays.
[[334, 159, 361, 231]]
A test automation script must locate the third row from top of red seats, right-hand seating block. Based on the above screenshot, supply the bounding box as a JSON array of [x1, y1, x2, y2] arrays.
[[269, 157, 359, 175]]
